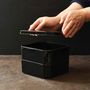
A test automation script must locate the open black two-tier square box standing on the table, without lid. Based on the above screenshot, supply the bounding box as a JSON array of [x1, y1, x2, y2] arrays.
[[21, 42, 69, 78]]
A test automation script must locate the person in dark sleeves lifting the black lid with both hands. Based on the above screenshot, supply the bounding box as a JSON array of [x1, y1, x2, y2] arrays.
[[29, 0, 90, 38]]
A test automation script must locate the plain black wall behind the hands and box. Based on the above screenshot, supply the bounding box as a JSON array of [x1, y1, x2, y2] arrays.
[[0, 0, 90, 54]]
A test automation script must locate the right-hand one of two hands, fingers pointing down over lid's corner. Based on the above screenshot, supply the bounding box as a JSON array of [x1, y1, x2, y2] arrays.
[[60, 9, 85, 38]]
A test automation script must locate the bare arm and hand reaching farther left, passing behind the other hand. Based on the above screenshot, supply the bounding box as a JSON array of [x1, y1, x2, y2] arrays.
[[29, 2, 82, 31]]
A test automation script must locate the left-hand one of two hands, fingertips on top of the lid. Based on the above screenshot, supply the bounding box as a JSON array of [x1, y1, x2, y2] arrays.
[[29, 17, 60, 31]]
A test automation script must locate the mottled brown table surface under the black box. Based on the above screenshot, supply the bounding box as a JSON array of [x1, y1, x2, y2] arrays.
[[0, 55, 90, 90]]
